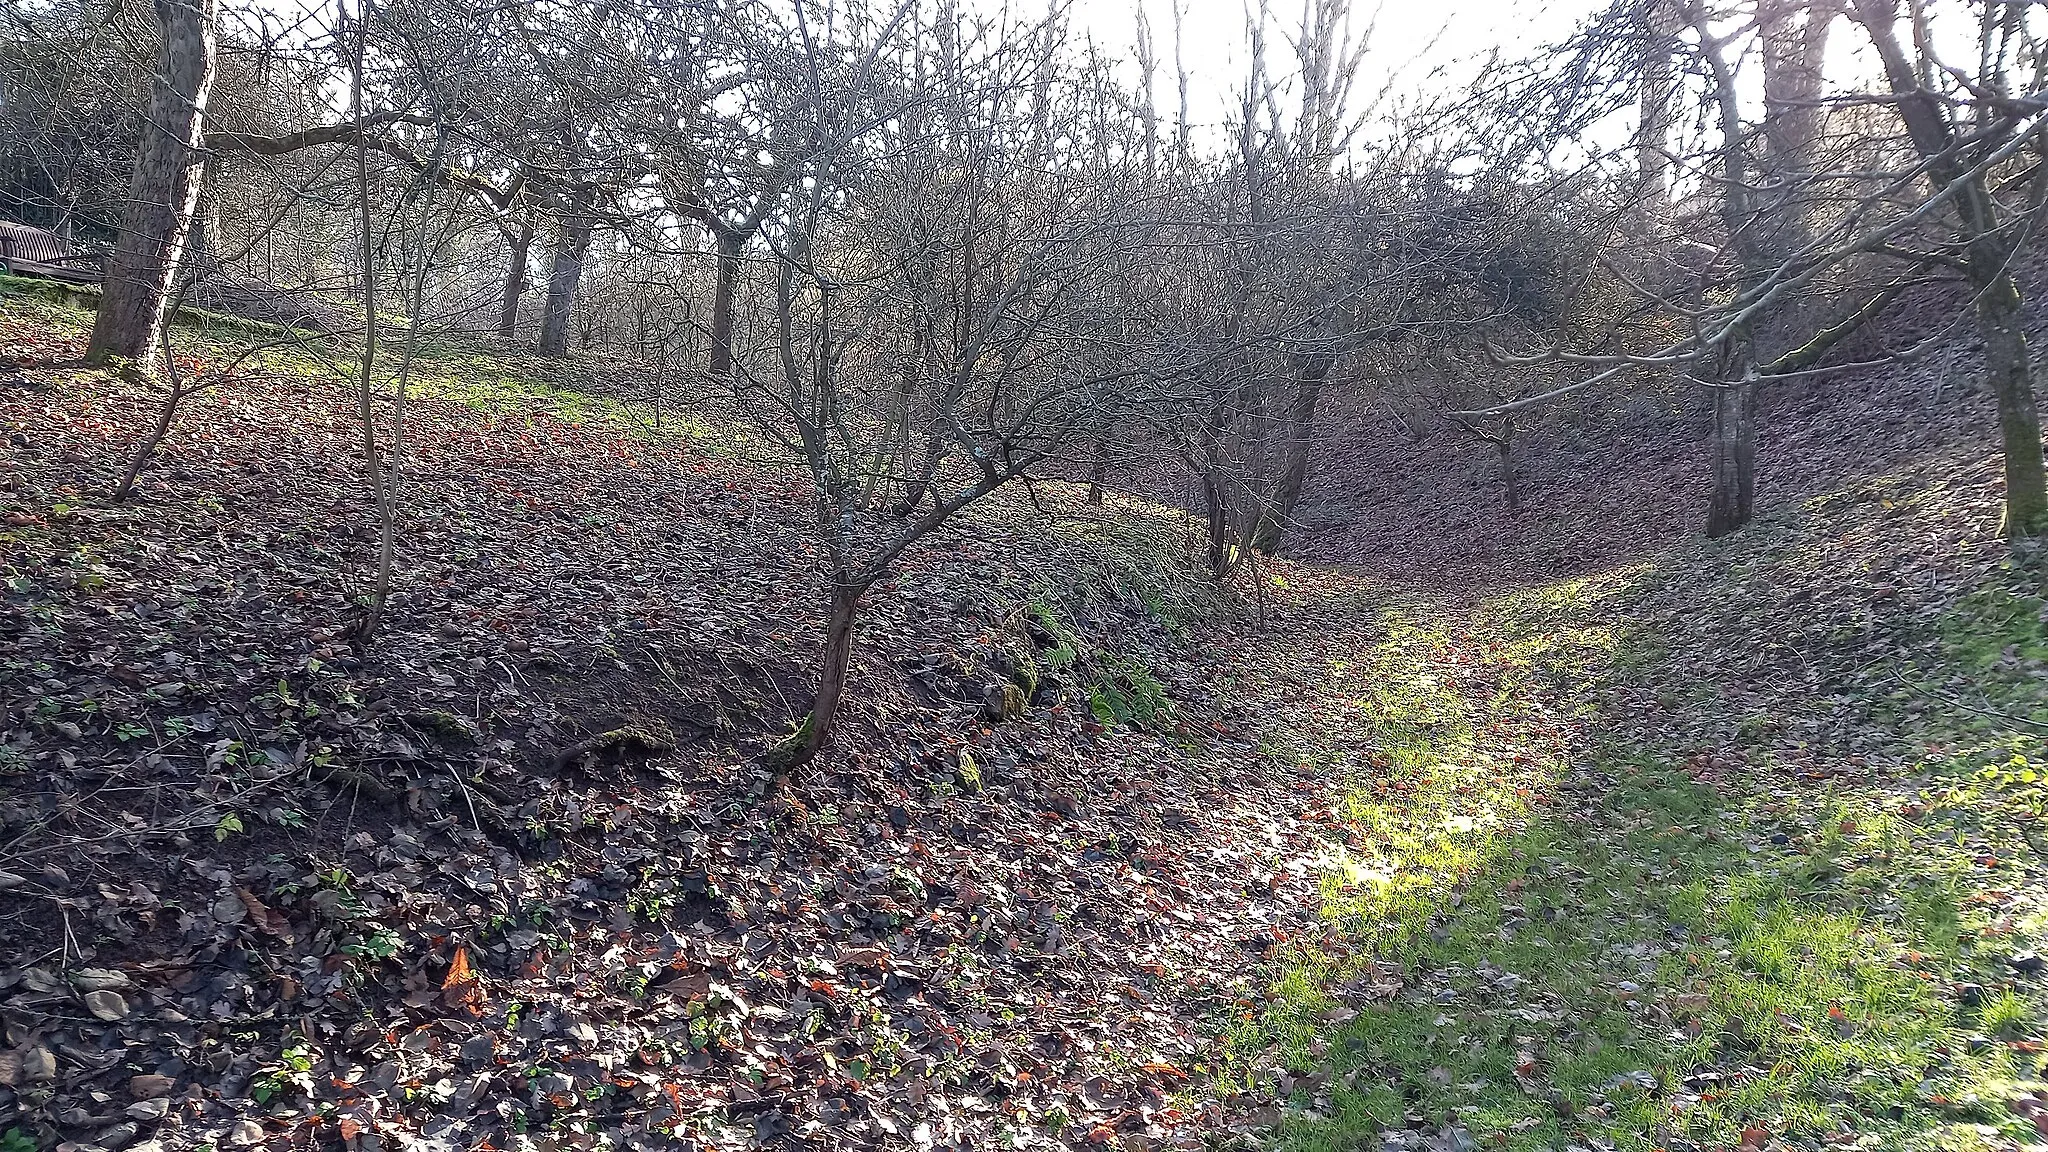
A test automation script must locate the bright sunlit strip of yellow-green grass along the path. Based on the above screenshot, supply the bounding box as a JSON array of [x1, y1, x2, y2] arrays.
[[1219, 582, 1616, 1090]]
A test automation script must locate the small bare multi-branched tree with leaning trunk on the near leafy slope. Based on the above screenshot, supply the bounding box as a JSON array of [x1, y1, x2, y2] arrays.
[[708, 2, 1149, 771]]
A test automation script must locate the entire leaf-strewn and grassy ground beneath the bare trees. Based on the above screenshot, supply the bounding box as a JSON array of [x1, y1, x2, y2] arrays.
[[0, 285, 2048, 1152]]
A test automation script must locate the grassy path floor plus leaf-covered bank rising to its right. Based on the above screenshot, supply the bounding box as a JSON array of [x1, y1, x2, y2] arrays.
[[1233, 282, 2048, 1150]]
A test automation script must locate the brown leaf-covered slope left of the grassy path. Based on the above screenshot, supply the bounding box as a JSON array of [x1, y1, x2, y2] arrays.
[[0, 291, 1376, 1148]]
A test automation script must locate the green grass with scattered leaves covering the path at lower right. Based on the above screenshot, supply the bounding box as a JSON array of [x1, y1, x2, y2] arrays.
[[1219, 561, 2048, 1152]]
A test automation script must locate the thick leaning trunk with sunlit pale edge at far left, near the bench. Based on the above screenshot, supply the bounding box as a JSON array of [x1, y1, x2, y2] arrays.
[[86, 0, 215, 371]]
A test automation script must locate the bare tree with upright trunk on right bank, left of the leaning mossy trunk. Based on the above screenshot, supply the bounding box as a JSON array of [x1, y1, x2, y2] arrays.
[[1456, 0, 1954, 537]]
